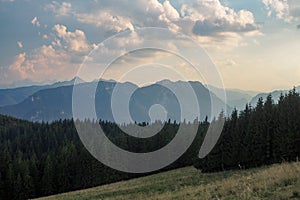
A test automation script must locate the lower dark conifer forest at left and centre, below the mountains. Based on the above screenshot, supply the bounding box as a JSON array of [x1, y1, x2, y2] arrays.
[[0, 116, 208, 199]]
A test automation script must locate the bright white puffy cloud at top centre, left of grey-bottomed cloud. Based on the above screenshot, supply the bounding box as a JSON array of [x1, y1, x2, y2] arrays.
[[74, 0, 180, 32]]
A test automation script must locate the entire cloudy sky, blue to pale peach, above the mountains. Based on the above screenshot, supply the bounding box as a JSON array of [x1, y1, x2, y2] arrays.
[[0, 0, 300, 91]]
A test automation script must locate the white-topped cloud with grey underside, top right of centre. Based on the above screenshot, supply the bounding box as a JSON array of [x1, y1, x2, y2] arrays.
[[181, 0, 259, 36]]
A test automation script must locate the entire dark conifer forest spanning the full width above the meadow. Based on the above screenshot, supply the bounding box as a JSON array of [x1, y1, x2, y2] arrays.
[[0, 90, 300, 199]]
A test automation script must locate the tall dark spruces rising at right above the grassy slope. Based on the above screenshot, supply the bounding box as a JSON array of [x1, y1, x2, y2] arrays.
[[194, 89, 300, 172]]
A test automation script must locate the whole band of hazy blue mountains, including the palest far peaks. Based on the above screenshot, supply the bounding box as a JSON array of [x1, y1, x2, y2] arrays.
[[0, 78, 298, 122]]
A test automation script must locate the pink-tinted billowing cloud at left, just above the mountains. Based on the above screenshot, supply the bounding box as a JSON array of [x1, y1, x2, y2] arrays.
[[0, 24, 92, 84]]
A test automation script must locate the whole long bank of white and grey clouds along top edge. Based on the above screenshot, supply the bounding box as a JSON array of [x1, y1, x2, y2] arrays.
[[46, 0, 259, 37]]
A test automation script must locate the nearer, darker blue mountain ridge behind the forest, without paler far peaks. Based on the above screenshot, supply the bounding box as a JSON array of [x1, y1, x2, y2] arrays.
[[0, 81, 232, 122]]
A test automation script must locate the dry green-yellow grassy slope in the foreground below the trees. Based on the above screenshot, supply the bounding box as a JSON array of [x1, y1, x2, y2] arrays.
[[37, 162, 300, 200]]
